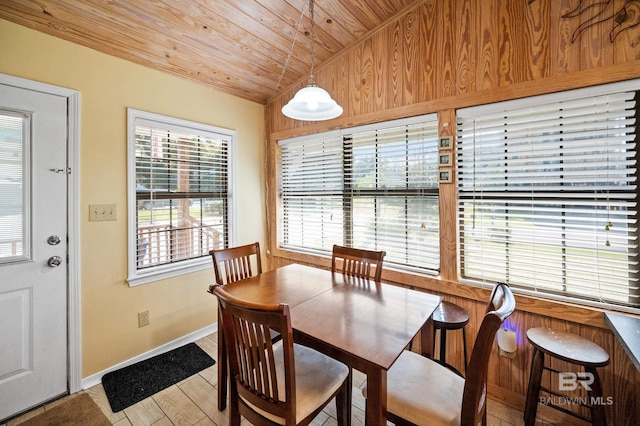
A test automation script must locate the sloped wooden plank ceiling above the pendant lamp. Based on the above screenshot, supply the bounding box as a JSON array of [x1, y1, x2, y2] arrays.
[[0, 0, 421, 104]]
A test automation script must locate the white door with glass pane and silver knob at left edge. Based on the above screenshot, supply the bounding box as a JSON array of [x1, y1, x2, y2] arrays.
[[0, 85, 68, 422]]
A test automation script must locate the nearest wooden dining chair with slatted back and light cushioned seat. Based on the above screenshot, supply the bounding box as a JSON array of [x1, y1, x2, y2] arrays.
[[213, 286, 351, 426]]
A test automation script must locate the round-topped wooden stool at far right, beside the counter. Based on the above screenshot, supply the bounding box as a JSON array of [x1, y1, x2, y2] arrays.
[[524, 327, 609, 426]]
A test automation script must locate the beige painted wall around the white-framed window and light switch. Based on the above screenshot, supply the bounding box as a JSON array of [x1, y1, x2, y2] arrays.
[[0, 20, 265, 377]]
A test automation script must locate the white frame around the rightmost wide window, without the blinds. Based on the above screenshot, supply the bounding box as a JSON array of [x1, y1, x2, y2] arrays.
[[456, 79, 640, 312]]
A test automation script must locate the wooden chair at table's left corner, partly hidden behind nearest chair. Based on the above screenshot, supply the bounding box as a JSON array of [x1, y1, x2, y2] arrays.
[[209, 242, 280, 411]]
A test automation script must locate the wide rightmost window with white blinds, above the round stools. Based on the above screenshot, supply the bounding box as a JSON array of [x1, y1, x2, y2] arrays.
[[457, 81, 640, 307]]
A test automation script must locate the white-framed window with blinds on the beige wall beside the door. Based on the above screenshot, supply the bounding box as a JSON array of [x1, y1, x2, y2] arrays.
[[129, 110, 233, 282]]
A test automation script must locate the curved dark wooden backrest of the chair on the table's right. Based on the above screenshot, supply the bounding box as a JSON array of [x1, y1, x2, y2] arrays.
[[460, 283, 516, 425]]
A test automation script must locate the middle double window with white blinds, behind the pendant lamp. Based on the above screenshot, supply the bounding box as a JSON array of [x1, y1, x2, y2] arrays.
[[280, 114, 440, 271]]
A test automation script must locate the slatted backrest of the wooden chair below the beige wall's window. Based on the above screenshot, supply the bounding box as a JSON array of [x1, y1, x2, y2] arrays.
[[209, 242, 262, 285]]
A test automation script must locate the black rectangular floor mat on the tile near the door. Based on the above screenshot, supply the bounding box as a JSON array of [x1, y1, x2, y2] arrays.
[[102, 343, 215, 413]]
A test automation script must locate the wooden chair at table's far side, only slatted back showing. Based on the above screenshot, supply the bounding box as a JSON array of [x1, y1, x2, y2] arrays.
[[331, 245, 387, 282]]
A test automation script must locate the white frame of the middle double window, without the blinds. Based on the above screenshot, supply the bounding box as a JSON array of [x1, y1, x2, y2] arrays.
[[277, 113, 440, 276]]
